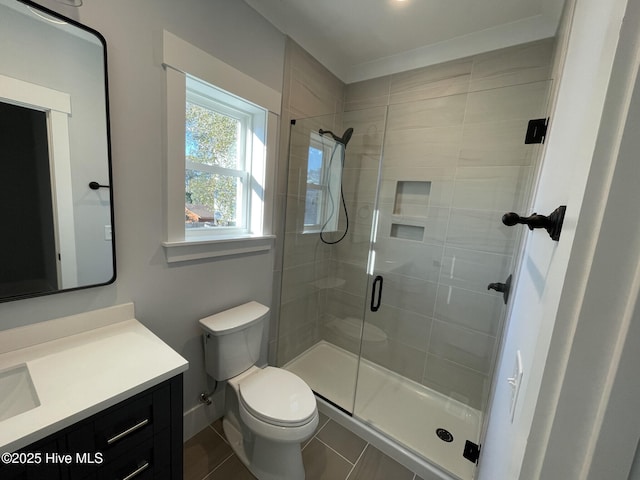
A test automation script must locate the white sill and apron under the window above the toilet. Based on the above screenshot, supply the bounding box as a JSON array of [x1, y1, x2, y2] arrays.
[[162, 235, 275, 263]]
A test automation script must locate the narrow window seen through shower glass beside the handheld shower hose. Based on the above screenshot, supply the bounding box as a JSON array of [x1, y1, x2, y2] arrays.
[[304, 132, 344, 233]]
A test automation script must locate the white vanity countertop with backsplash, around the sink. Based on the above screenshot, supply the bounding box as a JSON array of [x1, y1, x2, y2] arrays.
[[0, 304, 188, 452]]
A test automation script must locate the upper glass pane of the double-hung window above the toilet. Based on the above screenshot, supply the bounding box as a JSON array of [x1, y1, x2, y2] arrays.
[[185, 102, 243, 169]]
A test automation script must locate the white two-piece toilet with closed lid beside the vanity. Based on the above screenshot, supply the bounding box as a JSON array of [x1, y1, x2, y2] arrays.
[[200, 302, 318, 480]]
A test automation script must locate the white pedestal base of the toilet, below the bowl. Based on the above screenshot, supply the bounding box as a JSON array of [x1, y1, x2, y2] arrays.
[[222, 417, 305, 480]]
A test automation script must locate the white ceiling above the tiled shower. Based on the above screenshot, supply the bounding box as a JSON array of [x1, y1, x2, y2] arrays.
[[245, 0, 564, 83]]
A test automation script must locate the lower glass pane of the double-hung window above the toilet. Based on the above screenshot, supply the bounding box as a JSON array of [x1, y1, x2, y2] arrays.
[[185, 169, 244, 230]]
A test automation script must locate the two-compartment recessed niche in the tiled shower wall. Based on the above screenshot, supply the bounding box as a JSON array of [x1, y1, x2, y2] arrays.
[[389, 180, 431, 242]]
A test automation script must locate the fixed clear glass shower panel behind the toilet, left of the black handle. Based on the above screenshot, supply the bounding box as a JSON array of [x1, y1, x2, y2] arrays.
[[277, 107, 386, 413]]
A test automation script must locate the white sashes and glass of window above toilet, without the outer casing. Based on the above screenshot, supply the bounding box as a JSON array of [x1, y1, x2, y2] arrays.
[[185, 77, 266, 238]]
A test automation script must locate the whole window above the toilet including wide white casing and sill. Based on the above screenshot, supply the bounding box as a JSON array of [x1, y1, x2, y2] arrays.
[[162, 31, 281, 262]]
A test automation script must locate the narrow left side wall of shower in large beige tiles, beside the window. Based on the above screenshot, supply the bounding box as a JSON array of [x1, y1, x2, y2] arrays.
[[269, 39, 345, 365]]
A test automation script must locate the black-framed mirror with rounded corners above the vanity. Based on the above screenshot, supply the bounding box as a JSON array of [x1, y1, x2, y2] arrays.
[[0, 0, 115, 301]]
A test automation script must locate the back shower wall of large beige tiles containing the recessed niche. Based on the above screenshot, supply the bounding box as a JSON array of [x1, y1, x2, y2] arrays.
[[330, 40, 553, 410]]
